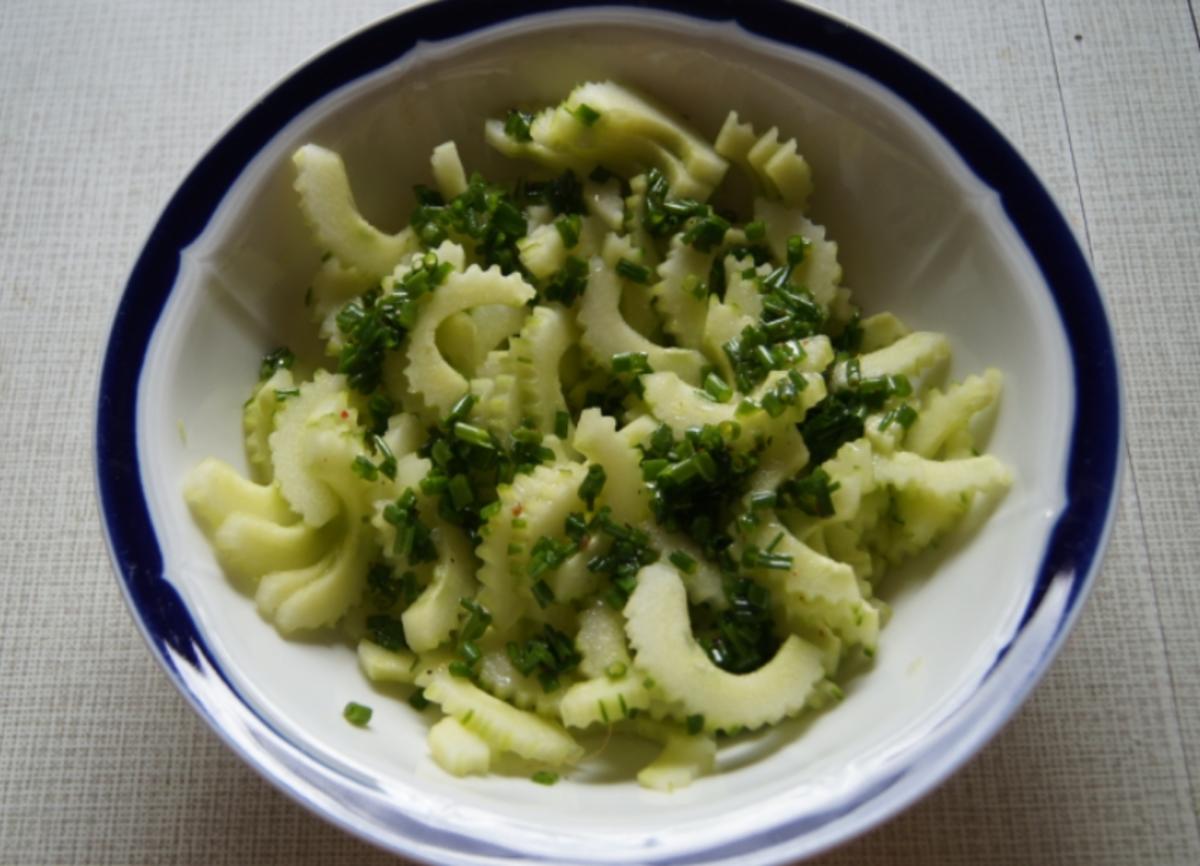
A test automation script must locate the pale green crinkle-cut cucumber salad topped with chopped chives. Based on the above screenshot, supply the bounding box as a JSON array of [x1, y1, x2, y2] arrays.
[[185, 82, 1010, 790]]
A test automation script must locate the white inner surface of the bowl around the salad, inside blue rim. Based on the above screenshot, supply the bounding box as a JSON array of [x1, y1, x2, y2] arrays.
[[129, 11, 1074, 858]]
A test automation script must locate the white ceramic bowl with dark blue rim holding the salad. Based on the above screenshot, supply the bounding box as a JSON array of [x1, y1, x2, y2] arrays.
[[97, 0, 1121, 864]]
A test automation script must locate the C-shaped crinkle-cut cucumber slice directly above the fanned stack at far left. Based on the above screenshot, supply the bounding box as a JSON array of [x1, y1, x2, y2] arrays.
[[269, 369, 354, 527]]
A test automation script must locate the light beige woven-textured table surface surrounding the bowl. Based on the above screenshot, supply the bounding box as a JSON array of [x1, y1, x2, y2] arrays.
[[0, 0, 1200, 866]]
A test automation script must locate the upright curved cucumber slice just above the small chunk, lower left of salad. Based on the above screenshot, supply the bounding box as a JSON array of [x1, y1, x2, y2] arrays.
[[400, 518, 475, 652]]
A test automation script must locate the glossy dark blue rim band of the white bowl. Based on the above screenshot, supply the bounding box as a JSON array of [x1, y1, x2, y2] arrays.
[[96, 0, 1123, 862]]
